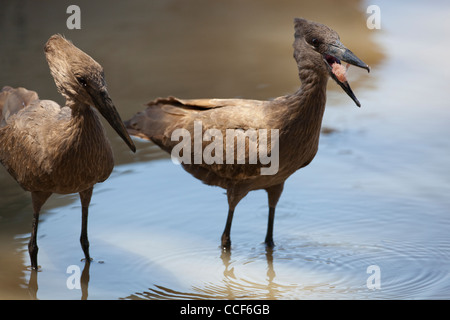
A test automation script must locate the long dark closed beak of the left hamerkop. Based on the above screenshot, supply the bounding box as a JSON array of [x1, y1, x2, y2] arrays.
[[89, 90, 136, 152]]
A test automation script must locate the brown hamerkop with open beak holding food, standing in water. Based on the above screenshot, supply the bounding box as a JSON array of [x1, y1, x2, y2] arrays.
[[125, 19, 370, 249]]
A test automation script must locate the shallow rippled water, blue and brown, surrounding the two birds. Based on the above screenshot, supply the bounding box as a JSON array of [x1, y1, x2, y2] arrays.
[[0, 0, 450, 299]]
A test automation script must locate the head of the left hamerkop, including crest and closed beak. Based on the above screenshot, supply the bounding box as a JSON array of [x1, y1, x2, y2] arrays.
[[44, 34, 136, 152]]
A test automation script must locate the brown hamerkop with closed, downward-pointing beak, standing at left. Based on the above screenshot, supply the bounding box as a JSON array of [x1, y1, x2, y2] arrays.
[[0, 35, 136, 269]]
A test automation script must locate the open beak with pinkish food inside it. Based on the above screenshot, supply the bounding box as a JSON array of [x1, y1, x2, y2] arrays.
[[323, 41, 370, 107]]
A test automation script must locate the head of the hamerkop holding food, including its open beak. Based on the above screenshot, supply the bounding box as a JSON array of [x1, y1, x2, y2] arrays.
[[293, 18, 370, 107]]
